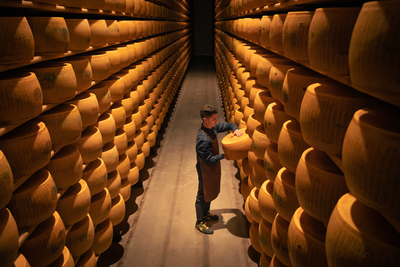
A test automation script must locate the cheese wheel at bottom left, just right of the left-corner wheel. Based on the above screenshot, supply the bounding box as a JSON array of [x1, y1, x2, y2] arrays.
[[19, 211, 65, 267]]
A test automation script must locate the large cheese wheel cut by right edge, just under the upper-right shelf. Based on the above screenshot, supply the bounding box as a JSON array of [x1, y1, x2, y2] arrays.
[[343, 106, 400, 218]]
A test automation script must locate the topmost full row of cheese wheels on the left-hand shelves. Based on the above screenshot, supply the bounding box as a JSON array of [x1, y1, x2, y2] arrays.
[[0, 17, 189, 67]]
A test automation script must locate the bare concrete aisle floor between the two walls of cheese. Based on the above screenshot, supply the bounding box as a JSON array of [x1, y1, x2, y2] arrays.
[[98, 56, 259, 267]]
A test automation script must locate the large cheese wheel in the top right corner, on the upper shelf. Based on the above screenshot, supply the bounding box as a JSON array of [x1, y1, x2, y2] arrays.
[[349, 1, 400, 106]]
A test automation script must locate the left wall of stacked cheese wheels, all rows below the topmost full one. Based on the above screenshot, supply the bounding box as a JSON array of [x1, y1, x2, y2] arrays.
[[0, 20, 192, 266]]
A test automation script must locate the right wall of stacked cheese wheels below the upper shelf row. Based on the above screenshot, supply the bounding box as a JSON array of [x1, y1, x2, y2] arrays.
[[215, 2, 400, 266]]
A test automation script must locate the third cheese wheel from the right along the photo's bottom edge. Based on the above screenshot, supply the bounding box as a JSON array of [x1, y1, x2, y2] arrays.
[[271, 213, 292, 266]]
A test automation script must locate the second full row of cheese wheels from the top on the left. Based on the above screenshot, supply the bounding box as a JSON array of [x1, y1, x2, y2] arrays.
[[0, 18, 189, 125]]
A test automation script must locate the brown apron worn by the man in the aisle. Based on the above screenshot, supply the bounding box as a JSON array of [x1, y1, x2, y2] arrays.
[[199, 131, 221, 202]]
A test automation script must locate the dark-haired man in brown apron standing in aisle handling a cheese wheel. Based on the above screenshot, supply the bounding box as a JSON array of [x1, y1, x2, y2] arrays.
[[195, 105, 243, 234]]
